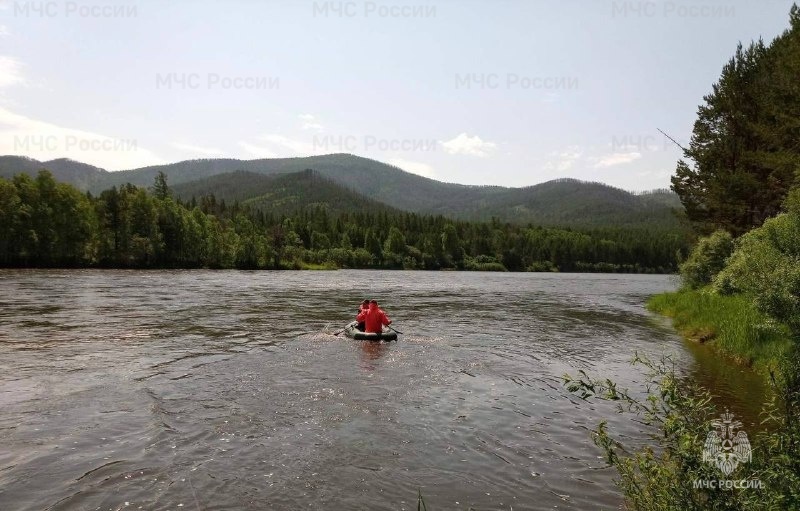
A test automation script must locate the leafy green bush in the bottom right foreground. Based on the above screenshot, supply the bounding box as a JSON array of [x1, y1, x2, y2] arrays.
[[565, 353, 800, 511]]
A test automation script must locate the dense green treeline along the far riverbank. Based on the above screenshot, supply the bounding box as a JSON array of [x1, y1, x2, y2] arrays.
[[0, 171, 689, 272]]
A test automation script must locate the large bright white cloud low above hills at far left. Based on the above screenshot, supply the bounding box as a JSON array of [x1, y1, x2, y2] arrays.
[[0, 107, 166, 170]]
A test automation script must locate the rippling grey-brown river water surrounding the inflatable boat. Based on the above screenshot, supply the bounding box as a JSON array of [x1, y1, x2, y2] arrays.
[[0, 270, 764, 511]]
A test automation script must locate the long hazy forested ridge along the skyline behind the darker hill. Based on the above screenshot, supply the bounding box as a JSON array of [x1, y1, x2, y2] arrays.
[[0, 154, 680, 229]]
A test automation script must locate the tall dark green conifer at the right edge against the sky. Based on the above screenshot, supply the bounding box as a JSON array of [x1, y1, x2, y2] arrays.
[[672, 6, 800, 235]]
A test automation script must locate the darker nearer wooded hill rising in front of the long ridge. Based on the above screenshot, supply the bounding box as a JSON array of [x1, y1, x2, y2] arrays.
[[172, 169, 392, 215]]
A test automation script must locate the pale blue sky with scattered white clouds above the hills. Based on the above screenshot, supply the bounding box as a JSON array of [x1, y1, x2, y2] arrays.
[[0, 0, 791, 191]]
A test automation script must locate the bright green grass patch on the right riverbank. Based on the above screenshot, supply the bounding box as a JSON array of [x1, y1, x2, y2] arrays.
[[647, 290, 792, 375]]
